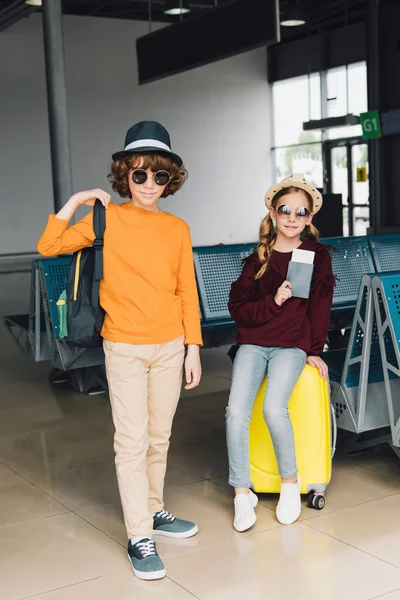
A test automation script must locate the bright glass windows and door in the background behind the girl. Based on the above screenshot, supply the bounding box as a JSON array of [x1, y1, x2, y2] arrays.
[[272, 62, 369, 235]]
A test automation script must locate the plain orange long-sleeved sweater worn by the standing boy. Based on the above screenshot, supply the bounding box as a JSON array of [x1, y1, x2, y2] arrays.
[[37, 202, 202, 345]]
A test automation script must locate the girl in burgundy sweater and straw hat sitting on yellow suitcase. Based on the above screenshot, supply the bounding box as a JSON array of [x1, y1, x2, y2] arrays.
[[226, 175, 335, 531]]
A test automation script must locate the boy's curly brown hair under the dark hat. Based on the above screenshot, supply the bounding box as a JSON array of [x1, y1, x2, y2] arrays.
[[108, 152, 188, 198]]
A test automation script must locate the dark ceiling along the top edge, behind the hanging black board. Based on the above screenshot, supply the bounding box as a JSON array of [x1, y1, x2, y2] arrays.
[[0, 0, 398, 40]]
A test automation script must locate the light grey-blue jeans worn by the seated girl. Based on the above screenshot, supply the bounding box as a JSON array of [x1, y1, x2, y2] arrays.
[[226, 344, 307, 487]]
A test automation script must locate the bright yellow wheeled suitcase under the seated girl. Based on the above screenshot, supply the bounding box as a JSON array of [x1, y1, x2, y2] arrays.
[[250, 365, 336, 510]]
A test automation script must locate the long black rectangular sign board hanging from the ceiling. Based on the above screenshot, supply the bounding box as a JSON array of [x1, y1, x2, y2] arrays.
[[136, 0, 280, 84]]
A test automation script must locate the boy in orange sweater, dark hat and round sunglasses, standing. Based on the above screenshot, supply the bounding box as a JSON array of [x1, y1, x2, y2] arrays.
[[38, 121, 202, 579]]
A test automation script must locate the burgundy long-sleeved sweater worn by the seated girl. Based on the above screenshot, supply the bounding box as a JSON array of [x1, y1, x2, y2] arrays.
[[228, 240, 335, 356]]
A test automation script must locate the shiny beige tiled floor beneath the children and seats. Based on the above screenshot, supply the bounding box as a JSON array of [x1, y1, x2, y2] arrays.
[[0, 273, 400, 600]]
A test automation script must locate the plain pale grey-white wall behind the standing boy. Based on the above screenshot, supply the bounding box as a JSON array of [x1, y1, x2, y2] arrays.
[[0, 14, 271, 254]]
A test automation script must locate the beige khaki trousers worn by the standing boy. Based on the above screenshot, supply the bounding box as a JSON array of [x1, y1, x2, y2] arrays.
[[104, 337, 185, 538]]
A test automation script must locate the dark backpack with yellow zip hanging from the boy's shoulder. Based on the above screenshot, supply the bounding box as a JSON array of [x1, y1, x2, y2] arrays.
[[66, 199, 106, 348]]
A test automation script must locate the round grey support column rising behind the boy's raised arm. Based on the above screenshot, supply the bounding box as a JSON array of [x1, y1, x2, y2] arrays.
[[42, 0, 72, 212]]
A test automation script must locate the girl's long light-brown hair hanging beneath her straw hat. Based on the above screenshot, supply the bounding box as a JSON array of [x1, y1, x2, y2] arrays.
[[256, 187, 319, 279]]
